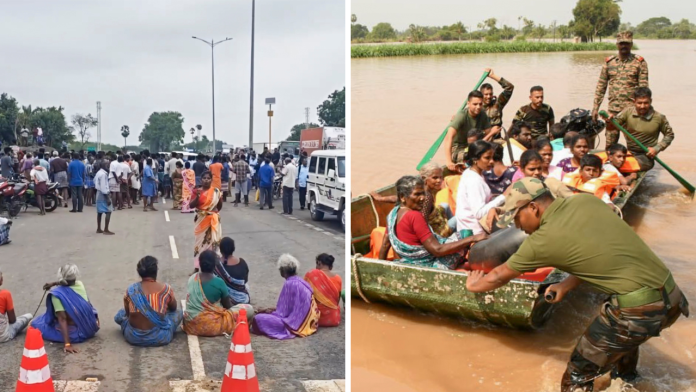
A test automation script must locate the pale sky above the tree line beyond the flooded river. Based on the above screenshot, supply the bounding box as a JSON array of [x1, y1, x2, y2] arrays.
[[351, 0, 696, 30]]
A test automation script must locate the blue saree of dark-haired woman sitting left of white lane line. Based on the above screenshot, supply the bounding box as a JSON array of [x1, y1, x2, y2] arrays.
[[114, 282, 183, 347]]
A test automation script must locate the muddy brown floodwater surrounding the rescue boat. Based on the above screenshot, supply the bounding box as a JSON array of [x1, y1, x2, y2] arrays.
[[351, 41, 696, 392]]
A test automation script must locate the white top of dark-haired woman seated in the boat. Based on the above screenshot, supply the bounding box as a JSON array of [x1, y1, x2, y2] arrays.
[[456, 169, 505, 234]]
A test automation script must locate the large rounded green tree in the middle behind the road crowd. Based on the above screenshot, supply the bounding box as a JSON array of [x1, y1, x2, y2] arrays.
[[138, 112, 185, 151]]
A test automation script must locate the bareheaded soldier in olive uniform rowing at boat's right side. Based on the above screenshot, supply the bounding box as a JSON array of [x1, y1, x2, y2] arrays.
[[610, 87, 674, 171]]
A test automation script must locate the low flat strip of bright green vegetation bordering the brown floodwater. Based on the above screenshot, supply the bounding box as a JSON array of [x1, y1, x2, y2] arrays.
[[350, 41, 616, 58]]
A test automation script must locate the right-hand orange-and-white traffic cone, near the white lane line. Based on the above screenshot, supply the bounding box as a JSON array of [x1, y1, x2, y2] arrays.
[[220, 309, 259, 392]]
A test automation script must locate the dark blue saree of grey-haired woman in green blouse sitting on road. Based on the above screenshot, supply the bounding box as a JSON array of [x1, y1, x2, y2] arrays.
[[31, 286, 99, 343]]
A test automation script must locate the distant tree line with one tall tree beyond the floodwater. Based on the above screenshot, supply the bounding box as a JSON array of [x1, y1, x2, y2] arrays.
[[351, 0, 696, 50]]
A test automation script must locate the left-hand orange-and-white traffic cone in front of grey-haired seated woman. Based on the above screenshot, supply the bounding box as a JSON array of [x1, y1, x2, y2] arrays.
[[15, 327, 55, 392]]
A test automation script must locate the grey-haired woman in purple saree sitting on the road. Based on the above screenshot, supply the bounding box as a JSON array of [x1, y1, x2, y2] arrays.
[[251, 254, 321, 340]]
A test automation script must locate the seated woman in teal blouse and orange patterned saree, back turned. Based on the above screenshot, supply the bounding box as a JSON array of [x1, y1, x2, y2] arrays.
[[183, 250, 254, 336]]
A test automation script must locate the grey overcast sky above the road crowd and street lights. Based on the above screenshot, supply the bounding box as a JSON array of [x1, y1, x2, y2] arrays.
[[0, 0, 347, 146]]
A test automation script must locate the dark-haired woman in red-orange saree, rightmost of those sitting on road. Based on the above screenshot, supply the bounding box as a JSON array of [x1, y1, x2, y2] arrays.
[[305, 253, 343, 327]]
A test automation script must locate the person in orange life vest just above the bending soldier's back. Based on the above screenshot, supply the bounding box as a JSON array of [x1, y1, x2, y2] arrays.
[[563, 154, 621, 203]]
